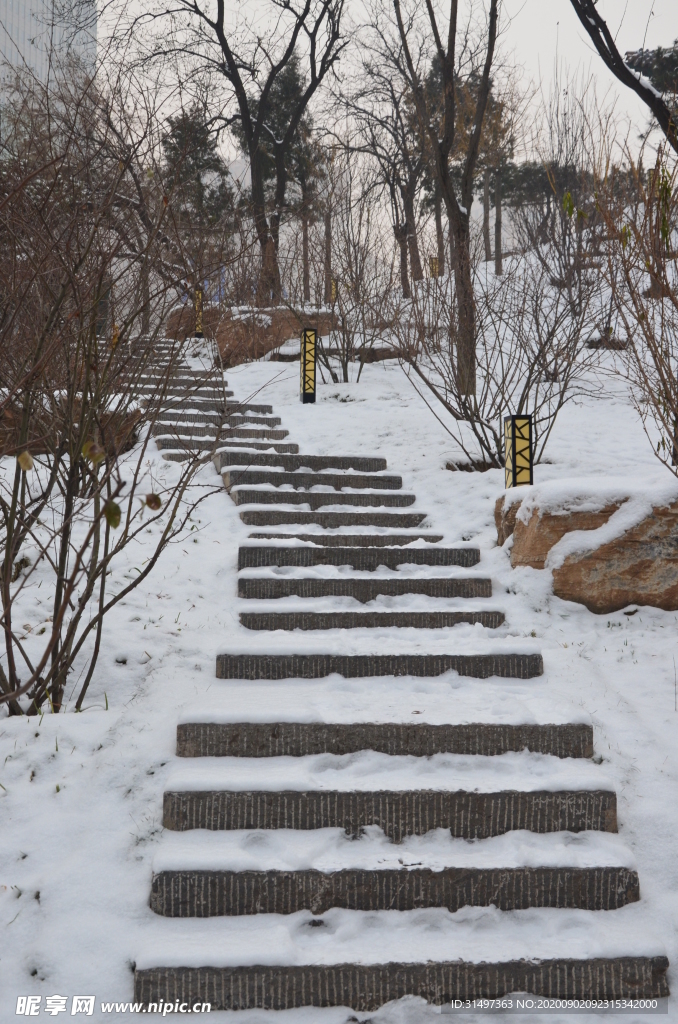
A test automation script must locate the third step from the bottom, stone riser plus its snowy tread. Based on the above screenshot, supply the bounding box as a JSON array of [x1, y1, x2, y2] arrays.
[[164, 751, 617, 843]]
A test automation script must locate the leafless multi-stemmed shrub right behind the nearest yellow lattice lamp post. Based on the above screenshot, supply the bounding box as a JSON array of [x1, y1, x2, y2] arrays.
[[393, 256, 596, 470]]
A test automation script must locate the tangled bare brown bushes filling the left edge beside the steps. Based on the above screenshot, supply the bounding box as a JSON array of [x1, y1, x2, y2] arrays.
[[0, 61, 223, 714]]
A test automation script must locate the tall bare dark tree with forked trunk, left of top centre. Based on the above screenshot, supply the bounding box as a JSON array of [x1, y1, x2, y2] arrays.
[[140, 0, 346, 305]]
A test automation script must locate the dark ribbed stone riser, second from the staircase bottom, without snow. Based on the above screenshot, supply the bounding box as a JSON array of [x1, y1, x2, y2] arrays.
[[151, 866, 640, 918]]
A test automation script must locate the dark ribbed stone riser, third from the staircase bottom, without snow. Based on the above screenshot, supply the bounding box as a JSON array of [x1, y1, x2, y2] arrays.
[[163, 790, 617, 843]]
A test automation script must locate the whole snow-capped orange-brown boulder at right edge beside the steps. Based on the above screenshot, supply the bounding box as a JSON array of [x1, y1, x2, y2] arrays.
[[495, 483, 678, 614]]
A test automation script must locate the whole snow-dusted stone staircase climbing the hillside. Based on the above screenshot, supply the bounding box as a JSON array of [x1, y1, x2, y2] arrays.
[[134, 356, 668, 1019]]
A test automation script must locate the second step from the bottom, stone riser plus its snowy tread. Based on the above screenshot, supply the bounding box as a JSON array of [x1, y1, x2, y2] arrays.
[[151, 826, 639, 916]]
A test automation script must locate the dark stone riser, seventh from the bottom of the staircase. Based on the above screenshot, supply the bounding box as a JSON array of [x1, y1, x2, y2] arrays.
[[238, 577, 492, 604]]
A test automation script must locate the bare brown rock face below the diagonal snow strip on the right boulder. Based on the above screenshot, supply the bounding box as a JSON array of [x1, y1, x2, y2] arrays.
[[553, 502, 678, 614]]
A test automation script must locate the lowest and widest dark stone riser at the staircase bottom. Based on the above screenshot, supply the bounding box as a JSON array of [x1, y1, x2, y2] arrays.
[[134, 956, 669, 1013]]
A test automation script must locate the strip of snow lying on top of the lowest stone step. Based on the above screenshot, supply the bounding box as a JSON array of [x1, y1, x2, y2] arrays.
[[137, 903, 664, 970]]
